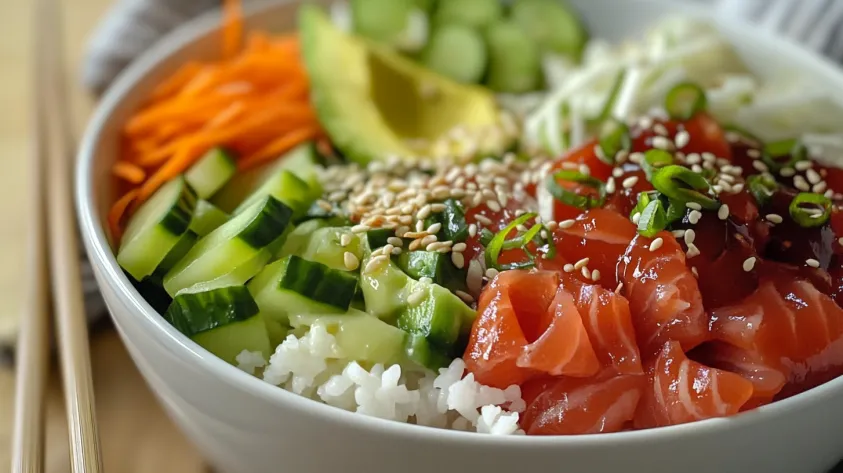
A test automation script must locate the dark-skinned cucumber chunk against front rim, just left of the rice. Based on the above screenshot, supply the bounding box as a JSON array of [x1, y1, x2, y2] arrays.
[[164, 286, 270, 364]]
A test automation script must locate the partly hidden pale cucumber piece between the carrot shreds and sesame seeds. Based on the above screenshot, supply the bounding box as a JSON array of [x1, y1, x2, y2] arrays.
[[211, 143, 322, 213]]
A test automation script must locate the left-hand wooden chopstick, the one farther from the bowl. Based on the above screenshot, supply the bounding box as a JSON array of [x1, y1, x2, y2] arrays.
[[11, 1, 50, 473]]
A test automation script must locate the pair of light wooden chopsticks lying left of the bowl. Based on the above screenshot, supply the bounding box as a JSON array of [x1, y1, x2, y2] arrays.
[[12, 0, 103, 473]]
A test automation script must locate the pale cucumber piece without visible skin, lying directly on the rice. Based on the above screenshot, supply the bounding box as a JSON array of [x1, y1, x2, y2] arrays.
[[290, 309, 407, 364]]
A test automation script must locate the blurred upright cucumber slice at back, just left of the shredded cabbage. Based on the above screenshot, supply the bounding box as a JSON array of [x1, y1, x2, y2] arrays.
[[486, 21, 541, 93]]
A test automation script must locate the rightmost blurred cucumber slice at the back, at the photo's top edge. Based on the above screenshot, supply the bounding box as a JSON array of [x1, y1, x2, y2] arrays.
[[511, 0, 588, 61]]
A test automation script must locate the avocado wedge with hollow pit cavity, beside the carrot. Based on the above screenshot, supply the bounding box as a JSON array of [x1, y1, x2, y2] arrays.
[[299, 5, 509, 164]]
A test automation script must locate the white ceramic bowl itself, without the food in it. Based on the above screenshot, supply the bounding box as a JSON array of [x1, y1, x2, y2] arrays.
[[76, 0, 843, 473]]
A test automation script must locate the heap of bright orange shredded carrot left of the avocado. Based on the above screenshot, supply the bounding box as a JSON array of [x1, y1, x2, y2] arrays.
[[108, 0, 324, 238]]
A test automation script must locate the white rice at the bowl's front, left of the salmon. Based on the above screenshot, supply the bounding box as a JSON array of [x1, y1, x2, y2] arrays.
[[237, 324, 526, 435]]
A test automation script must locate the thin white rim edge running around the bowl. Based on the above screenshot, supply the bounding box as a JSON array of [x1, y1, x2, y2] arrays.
[[74, 0, 843, 449]]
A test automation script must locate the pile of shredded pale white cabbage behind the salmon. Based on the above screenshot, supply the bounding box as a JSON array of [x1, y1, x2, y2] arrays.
[[516, 18, 843, 160]]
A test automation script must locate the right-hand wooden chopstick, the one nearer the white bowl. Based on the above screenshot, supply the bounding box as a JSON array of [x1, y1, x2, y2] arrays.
[[36, 0, 103, 473]]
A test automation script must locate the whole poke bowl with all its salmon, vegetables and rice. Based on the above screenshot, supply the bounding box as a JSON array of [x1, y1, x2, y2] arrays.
[[76, 0, 843, 473]]
